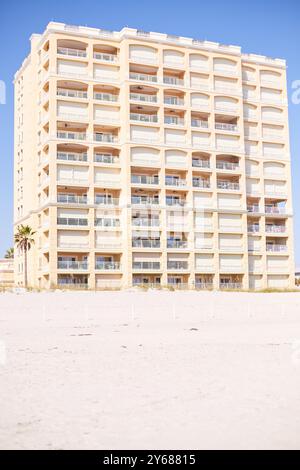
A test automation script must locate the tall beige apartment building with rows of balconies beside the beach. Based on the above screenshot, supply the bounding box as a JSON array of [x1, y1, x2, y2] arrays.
[[14, 23, 295, 290]]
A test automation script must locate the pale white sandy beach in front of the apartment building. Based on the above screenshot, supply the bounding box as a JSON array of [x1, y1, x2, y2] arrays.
[[0, 291, 300, 450]]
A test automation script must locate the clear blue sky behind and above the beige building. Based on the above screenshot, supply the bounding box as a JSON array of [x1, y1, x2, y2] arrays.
[[0, 0, 300, 266]]
